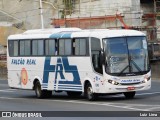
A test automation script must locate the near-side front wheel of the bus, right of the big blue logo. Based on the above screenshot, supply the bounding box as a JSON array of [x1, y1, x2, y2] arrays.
[[85, 83, 97, 101]]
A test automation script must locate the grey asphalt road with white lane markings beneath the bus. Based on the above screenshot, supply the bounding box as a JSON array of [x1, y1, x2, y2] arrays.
[[0, 80, 160, 120]]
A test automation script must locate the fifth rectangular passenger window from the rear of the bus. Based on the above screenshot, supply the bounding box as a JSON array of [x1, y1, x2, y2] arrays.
[[58, 39, 72, 55]]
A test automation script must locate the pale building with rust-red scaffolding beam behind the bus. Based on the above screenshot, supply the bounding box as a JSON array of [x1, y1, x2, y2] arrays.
[[52, 0, 160, 41]]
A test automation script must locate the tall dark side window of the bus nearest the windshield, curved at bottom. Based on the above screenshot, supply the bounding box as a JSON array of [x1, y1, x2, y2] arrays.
[[91, 38, 103, 74]]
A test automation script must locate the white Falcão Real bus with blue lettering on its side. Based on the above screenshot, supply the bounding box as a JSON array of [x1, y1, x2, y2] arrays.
[[7, 28, 151, 100]]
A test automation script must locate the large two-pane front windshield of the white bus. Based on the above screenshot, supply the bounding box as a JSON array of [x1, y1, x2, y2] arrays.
[[104, 36, 149, 76]]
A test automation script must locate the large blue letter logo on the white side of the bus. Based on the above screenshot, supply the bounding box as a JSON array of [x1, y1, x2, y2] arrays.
[[43, 57, 81, 84]]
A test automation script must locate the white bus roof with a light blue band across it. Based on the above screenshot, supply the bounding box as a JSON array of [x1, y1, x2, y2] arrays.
[[8, 28, 145, 40]]
